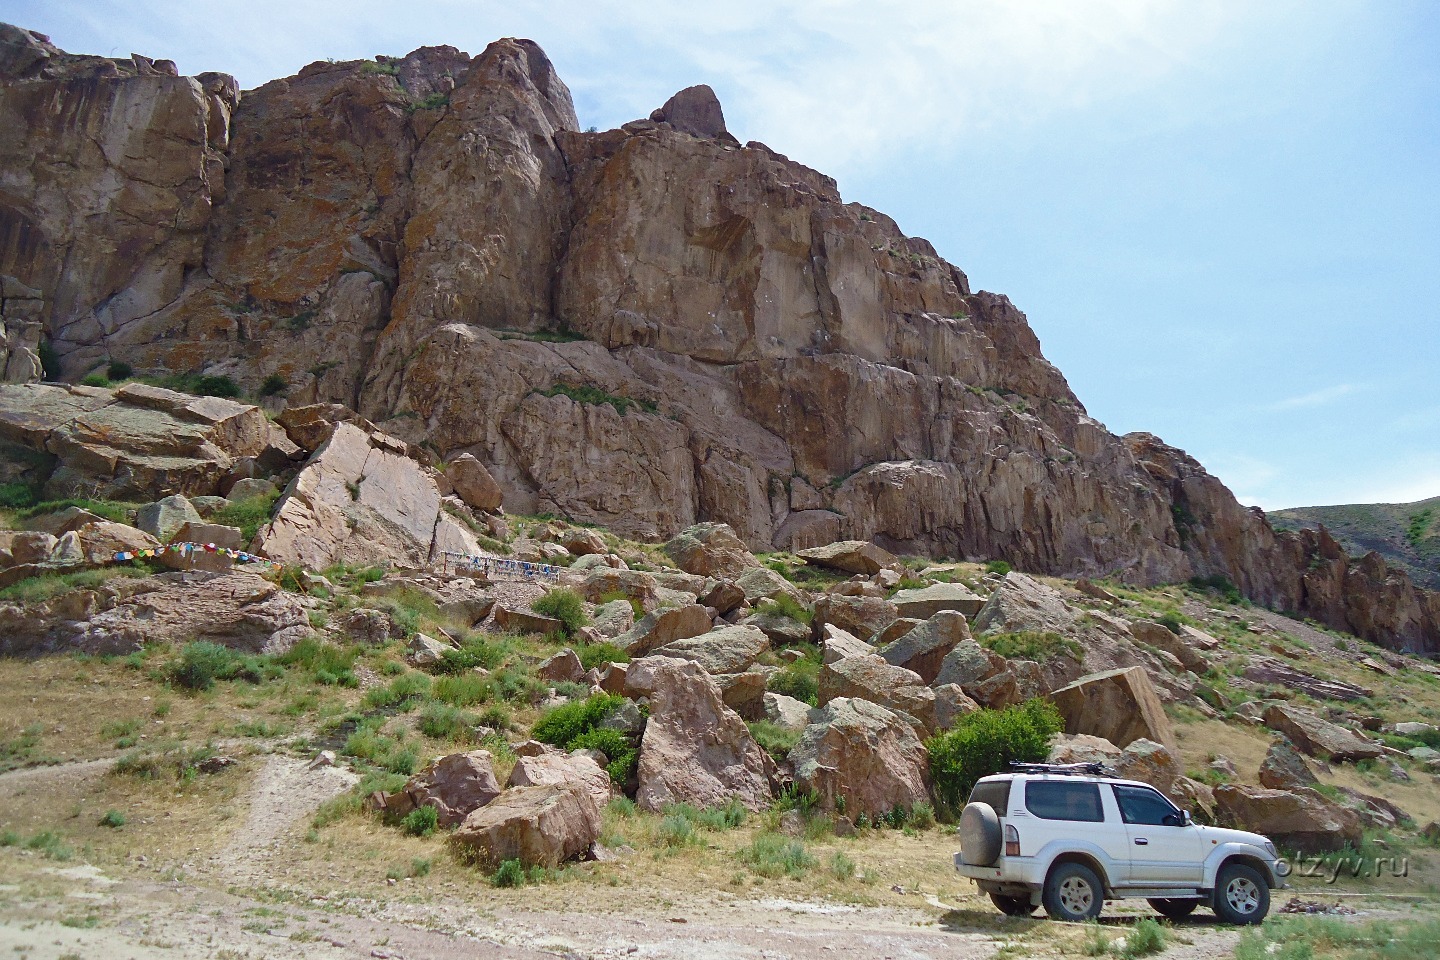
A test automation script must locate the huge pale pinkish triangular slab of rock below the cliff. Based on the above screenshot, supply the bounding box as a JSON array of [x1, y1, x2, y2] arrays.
[[256, 423, 480, 570]]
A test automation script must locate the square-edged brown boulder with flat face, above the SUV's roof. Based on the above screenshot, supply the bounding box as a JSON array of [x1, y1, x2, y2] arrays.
[[1050, 666, 1179, 753]]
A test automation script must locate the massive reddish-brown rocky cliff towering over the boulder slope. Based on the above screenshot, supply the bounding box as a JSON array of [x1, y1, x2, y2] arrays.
[[0, 27, 1440, 651]]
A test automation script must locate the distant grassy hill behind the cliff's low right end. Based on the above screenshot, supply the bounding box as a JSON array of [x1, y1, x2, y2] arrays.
[[1267, 497, 1440, 590]]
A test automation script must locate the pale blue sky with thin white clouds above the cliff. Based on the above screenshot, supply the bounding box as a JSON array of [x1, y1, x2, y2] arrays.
[[11, 0, 1440, 510]]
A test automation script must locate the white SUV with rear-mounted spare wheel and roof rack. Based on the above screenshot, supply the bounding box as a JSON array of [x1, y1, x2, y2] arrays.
[[955, 764, 1284, 924]]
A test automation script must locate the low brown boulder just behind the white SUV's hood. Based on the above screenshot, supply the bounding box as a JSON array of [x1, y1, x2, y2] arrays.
[[1214, 783, 1362, 853]]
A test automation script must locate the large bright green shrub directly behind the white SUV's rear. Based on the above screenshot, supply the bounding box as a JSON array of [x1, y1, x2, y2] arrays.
[[926, 698, 1064, 812]]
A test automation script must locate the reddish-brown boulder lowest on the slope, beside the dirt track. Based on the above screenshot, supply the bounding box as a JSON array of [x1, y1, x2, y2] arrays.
[[451, 782, 600, 869]]
